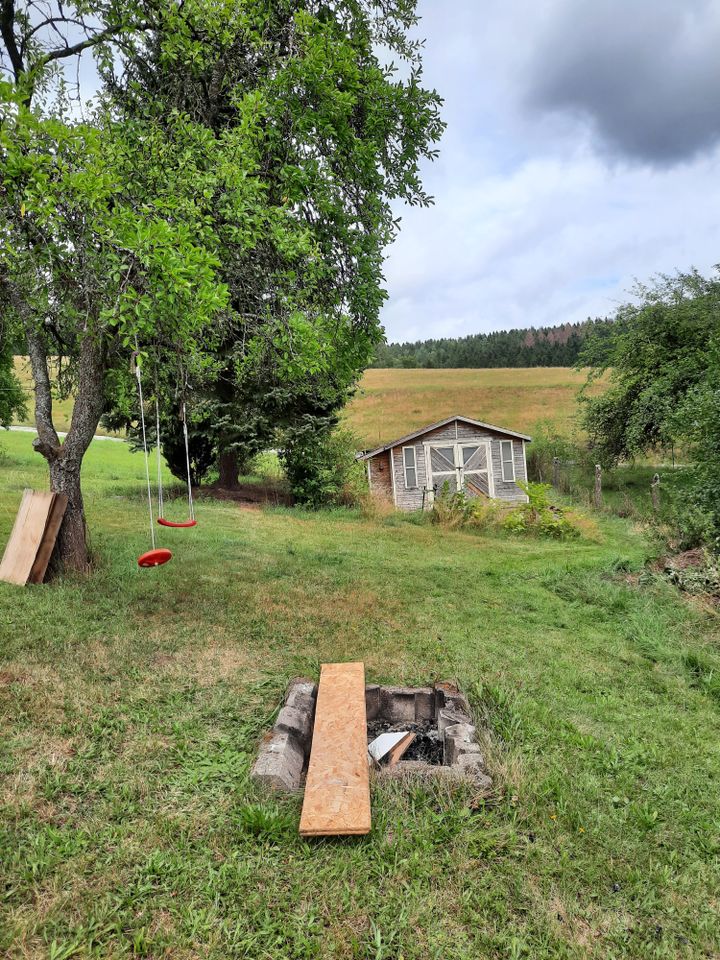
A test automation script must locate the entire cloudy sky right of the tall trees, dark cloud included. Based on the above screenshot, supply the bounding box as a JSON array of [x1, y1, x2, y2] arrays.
[[382, 0, 720, 342]]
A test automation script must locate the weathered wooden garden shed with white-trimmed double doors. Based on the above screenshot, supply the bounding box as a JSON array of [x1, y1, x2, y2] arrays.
[[360, 416, 531, 510]]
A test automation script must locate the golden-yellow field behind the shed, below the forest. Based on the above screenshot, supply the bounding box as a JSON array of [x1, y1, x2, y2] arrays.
[[345, 367, 602, 446]]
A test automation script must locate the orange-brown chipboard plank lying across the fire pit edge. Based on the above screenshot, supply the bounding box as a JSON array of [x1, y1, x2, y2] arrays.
[[300, 663, 370, 837]]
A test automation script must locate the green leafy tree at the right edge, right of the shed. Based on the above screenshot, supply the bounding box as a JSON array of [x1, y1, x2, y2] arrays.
[[582, 271, 720, 544]]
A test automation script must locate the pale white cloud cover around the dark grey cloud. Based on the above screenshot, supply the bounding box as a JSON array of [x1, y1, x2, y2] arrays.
[[383, 0, 720, 340]]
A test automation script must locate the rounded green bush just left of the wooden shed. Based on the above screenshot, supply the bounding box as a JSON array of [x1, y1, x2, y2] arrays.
[[280, 417, 367, 509]]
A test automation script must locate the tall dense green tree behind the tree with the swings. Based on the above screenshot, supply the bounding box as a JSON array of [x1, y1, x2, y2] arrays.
[[104, 0, 442, 484]]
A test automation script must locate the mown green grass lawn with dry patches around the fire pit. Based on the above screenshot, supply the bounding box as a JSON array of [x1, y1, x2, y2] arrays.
[[0, 432, 720, 960]]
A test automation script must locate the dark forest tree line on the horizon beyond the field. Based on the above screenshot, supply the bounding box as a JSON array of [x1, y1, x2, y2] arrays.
[[372, 319, 612, 369]]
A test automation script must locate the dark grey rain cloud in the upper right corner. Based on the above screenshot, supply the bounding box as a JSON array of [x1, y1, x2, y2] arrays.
[[526, 0, 720, 165]]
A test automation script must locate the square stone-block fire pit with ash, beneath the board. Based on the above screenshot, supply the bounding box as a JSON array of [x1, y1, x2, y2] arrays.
[[252, 678, 491, 790]]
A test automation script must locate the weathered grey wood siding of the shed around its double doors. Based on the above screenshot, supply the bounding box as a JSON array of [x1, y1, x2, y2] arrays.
[[386, 420, 527, 510]]
